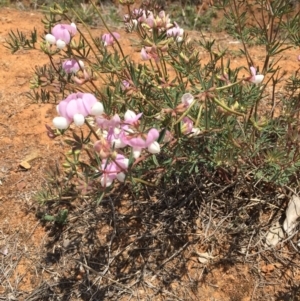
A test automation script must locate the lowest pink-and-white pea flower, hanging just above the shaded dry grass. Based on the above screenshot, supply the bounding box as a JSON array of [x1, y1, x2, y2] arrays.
[[100, 154, 129, 187]]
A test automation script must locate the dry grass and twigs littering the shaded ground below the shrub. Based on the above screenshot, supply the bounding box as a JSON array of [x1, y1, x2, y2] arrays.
[[2, 165, 299, 301]]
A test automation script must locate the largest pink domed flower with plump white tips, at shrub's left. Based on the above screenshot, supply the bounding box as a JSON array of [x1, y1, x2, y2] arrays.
[[53, 92, 104, 129]]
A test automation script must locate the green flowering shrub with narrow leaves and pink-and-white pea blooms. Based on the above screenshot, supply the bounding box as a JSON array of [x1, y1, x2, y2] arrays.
[[5, 1, 300, 204]]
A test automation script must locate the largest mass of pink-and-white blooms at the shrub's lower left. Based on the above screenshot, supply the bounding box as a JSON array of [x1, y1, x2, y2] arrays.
[[53, 92, 160, 187]]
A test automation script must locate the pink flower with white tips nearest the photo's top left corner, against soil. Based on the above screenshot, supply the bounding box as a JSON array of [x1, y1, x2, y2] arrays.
[[45, 23, 77, 49]]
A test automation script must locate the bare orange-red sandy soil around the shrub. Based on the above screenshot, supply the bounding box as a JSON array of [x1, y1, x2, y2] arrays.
[[0, 2, 298, 301]]
